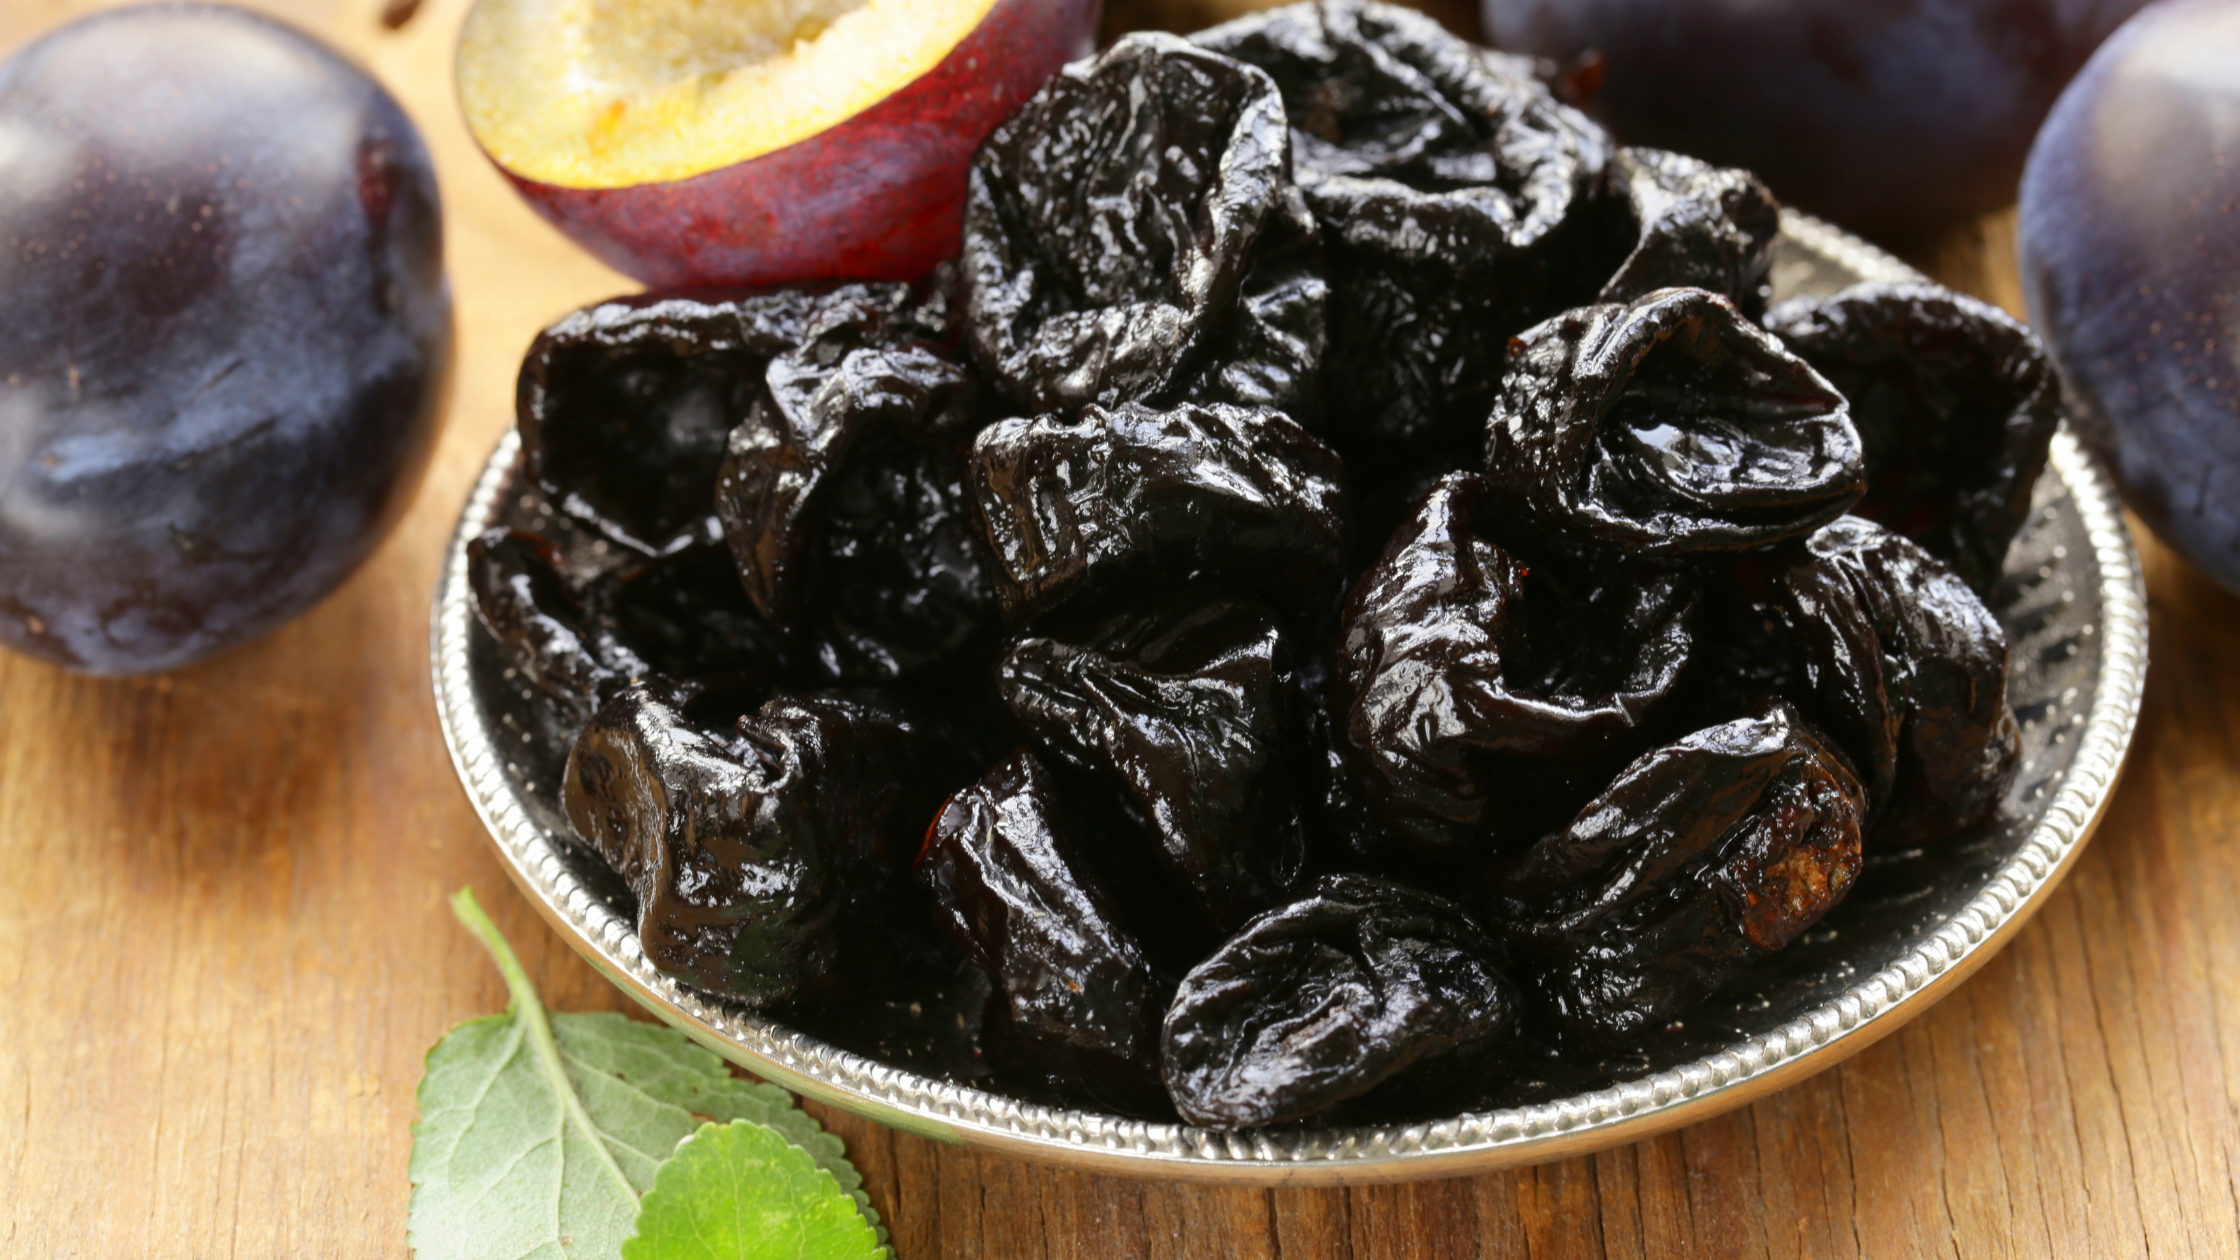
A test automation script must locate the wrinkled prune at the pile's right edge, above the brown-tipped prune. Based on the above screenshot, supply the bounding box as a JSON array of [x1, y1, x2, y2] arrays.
[[1776, 516, 2023, 847]]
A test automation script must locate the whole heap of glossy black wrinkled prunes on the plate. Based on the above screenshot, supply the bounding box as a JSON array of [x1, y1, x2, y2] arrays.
[[470, 0, 2052, 1128]]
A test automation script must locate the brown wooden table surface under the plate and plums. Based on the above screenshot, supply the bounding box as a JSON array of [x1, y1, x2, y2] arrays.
[[0, 0, 2240, 1260]]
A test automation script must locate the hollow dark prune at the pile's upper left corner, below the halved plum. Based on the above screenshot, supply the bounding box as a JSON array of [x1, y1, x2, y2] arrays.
[[513, 285, 912, 554]]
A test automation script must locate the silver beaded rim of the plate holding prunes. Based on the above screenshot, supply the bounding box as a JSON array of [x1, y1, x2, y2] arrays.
[[430, 211, 2146, 1184]]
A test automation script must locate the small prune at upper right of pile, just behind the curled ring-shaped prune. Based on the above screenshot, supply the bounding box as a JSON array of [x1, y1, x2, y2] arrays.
[[1597, 148, 1781, 314]]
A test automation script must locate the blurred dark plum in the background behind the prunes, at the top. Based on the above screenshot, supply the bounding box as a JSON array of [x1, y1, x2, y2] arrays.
[[1483, 0, 2144, 235]]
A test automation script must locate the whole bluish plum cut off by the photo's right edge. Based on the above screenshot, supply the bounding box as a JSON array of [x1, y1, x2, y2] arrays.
[[2023, 0, 2240, 590]]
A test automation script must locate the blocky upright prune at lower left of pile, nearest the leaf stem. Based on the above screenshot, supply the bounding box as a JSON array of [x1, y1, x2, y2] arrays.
[[560, 682, 954, 1004]]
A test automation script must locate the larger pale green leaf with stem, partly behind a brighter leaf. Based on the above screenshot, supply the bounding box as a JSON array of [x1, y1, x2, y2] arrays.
[[408, 890, 883, 1260]]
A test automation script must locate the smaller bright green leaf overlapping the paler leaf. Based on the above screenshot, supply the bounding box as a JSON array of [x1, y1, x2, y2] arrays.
[[623, 1121, 883, 1260]]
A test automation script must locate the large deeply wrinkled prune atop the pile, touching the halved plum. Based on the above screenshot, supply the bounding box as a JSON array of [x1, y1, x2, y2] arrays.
[[963, 34, 1326, 419]]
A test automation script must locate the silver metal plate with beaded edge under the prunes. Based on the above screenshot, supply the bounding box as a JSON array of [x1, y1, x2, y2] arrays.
[[432, 213, 2146, 1184]]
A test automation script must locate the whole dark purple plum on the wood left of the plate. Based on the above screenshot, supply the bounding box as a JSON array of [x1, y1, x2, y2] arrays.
[[0, 4, 450, 673]]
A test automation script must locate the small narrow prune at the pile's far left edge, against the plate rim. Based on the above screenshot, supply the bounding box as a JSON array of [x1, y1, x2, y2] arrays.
[[466, 529, 645, 726]]
